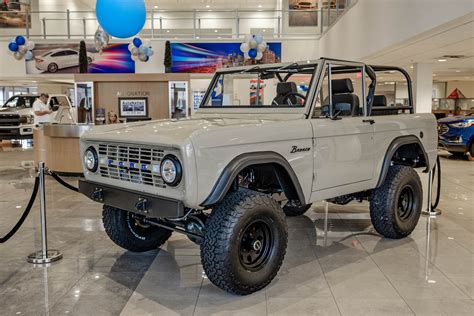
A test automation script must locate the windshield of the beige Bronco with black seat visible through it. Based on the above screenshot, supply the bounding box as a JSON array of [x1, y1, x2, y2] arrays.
[[203, 65, 316, 108]]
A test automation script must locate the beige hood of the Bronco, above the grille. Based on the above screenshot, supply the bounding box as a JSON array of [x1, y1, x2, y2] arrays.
[[82, 118, 286, 146]]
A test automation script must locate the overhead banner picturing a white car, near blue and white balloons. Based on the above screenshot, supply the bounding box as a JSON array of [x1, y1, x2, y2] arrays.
[[26, 44, 135, 74]]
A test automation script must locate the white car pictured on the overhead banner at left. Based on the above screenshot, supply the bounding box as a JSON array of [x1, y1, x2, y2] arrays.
[[35, 48, 94, 73]]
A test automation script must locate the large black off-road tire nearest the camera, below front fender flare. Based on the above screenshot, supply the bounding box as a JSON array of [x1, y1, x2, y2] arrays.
[[201, 190, 288, 295]]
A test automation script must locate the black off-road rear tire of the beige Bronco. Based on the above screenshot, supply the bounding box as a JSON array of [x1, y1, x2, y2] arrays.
[[370, 166, 423, 239]]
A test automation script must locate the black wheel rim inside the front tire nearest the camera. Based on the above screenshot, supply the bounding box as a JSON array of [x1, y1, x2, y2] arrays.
[[239, 219, 274, 271]]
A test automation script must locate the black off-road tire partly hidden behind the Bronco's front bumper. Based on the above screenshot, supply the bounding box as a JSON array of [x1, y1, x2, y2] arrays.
[[102, 205, 172, 252]]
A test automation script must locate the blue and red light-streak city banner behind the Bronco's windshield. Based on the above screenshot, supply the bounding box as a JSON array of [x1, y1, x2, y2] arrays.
[[171, 42, 281, 73]]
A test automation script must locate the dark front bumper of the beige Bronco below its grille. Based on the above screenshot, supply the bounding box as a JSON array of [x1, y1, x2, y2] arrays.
[[79, 180, 184, 218]]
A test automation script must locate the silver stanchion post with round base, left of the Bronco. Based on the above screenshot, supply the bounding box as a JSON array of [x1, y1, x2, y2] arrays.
[[27, 161, 63, 264]]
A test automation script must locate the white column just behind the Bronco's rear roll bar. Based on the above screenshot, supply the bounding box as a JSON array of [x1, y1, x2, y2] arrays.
[[413, 63, 433, 113]]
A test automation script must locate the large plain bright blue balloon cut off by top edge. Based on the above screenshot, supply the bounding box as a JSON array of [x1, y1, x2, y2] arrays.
[[95, 0, 146, 38]]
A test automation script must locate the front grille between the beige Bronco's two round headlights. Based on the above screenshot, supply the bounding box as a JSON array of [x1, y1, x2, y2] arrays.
[[99, 144, 166, 188]]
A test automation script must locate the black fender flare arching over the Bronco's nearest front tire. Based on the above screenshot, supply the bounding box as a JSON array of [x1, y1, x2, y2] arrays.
[[201, 151, 306, 207]]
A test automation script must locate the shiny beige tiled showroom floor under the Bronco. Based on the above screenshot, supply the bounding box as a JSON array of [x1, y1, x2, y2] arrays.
[[0, 150, 474, 315]]
